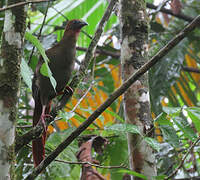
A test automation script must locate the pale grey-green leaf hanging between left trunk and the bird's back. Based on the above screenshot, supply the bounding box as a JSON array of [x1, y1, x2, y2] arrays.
[[20, 58, 32, 89]]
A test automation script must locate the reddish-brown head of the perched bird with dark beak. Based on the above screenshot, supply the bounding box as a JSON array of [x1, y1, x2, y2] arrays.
[[65, 19, 88, 35]]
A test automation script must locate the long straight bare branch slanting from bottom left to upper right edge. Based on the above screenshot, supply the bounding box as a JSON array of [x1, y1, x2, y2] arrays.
[[26, 13, 200, 180]]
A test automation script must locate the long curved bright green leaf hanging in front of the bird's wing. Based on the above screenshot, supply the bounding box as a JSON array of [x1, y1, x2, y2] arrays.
[[25, 32, 56, 90]]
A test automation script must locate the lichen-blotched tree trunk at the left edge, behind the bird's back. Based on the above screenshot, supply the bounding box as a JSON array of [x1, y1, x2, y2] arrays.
[[0, 0, 26, 180]]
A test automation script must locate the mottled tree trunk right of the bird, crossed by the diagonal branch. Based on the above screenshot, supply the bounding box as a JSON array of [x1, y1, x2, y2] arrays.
[[120, 0, 156, 179]]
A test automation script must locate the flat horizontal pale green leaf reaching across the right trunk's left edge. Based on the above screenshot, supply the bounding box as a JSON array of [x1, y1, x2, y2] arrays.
[[105, 124, 141, 134]]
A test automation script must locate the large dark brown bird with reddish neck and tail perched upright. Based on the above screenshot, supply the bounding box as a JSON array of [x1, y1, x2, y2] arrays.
[[32, 19, 88, 167]]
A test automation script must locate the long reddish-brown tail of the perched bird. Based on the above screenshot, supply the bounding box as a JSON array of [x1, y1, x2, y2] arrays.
[[32, 95, 46, 167]]
